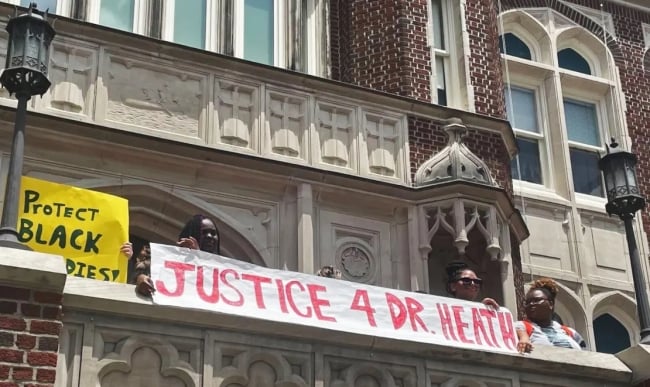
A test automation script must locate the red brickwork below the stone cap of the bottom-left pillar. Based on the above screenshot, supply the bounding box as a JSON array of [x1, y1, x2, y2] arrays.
[[0, 286, 61, 387]]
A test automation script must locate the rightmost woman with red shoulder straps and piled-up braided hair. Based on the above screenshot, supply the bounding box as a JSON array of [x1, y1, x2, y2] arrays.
[[515, 278, 585, 349]]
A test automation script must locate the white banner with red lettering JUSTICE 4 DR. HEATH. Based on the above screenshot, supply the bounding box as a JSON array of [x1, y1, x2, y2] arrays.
[[151, 244, 517, 353]]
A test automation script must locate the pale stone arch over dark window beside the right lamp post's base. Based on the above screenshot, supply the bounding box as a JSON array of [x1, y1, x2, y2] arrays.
[[591, 290, 640, 345]]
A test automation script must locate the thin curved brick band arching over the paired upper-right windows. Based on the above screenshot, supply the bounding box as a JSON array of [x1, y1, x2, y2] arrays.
[[503, 0, 623, 65]]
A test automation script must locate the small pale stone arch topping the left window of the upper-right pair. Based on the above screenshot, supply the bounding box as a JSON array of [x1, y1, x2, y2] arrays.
[[499, 9, 552, 64]]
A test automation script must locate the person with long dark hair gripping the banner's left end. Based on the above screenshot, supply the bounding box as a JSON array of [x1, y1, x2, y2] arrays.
[[135, 215, 221, 297]]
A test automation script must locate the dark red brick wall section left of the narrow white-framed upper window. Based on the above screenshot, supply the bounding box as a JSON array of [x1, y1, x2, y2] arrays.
[[330, 0, 431, 101]]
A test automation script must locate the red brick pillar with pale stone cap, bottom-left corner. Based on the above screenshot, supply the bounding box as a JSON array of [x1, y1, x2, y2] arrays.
[[0, 247, 66, 387]]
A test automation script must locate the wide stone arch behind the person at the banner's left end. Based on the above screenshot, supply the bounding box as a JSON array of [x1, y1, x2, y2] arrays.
[[75, 179, 270, 266]]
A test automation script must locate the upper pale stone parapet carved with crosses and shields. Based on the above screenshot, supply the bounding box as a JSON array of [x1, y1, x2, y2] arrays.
[[0, 4, 516, 188]]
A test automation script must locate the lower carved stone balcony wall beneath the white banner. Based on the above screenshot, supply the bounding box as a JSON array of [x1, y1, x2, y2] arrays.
[[57, 277, 632, 387]]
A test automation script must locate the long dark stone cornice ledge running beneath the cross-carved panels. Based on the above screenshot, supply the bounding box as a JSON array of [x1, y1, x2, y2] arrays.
[[0, 106, 529, 241]]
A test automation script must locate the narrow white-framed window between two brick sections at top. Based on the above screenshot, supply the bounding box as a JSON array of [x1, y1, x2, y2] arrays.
[[428, 0, 460, 109]]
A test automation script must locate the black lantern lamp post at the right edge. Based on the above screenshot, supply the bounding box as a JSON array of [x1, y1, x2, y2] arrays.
[[598, 139, 650, 344]]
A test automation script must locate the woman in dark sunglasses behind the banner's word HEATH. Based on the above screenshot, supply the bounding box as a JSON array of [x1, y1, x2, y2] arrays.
[[446, 262, 533, 353]]
